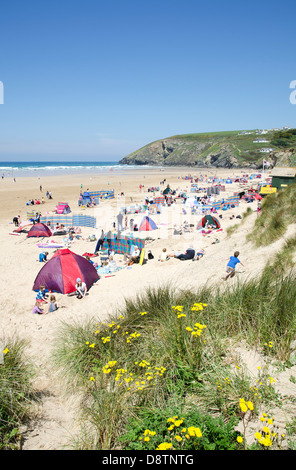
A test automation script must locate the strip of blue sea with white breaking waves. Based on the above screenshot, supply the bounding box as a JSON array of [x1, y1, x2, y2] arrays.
[[0, 161, 153, 179]]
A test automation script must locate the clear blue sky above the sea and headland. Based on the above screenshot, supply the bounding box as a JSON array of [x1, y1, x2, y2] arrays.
[[0, 0, 296, 161]]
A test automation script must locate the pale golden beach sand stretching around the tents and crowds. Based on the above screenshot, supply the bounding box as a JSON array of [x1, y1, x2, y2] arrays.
[[0, 168, 296, 450]]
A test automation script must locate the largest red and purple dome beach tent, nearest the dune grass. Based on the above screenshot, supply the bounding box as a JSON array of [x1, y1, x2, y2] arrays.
[[33, 248, 99, 294]]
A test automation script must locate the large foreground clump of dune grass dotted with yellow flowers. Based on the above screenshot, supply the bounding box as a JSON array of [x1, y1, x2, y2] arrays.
[[53, 266, 296, 449]]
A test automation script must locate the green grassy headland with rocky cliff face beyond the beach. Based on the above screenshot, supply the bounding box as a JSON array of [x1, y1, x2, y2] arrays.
[[120, 129, 296, 169]]
